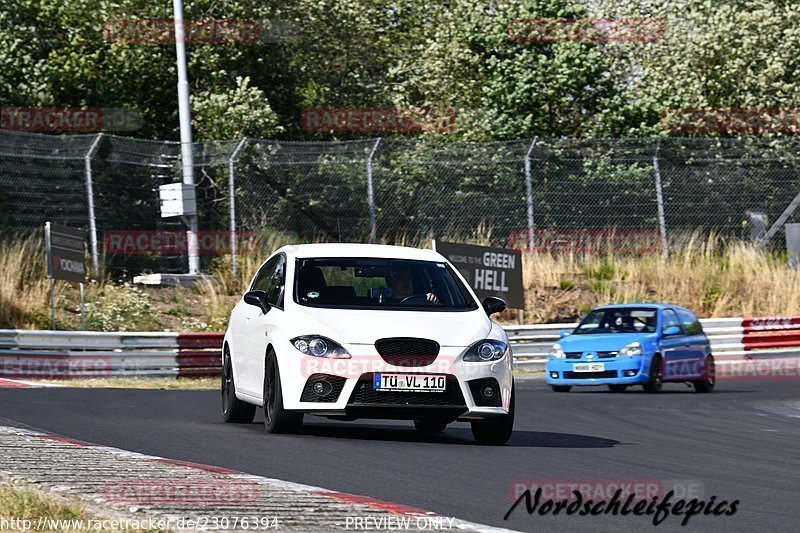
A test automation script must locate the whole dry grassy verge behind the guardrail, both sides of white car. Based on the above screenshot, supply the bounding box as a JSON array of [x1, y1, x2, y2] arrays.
[[0, 232, 800, 331]]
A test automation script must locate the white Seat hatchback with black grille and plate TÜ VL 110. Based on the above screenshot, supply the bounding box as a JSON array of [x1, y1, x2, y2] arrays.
[[222, 244, 514, 444]]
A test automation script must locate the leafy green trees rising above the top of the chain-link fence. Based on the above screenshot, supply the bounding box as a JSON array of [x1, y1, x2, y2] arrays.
[[0, 0, 800, 140]]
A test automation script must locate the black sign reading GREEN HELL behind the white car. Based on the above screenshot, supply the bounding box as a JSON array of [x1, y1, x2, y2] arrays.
[[434, 241, 525, 309]]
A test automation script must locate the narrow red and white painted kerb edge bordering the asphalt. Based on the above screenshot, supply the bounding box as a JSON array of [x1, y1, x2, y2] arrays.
[[0, 426, 513, 533]]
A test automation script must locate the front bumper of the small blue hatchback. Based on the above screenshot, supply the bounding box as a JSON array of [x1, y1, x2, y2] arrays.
[[545, 356, 649, 385]]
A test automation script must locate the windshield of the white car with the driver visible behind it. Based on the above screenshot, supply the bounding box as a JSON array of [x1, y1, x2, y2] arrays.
[[295, 257, 478, 311]]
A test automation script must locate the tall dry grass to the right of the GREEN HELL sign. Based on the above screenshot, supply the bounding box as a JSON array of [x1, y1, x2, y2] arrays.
[[523, 234, 800, 322]]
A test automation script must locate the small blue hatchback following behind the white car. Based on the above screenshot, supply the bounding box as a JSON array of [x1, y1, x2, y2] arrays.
[[546, 303, 715, 392]]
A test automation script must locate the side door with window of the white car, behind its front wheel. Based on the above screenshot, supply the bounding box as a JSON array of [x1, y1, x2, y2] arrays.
[[237, 254, 286, 398]]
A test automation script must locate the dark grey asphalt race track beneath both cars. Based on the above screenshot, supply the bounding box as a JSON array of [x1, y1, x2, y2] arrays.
[[0, 379, 800, 531]]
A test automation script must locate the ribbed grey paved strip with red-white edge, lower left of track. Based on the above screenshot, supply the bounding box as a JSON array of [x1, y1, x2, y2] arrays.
[[0, 426, 509, 533]]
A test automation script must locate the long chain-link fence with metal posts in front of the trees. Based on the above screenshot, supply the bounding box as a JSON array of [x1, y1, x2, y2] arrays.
[[0, 132, 800, 274]]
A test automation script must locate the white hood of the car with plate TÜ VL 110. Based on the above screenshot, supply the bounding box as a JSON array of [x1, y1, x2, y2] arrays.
[[288, 306, 492, 346]]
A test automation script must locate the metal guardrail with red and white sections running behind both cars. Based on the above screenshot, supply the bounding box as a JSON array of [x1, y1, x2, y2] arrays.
[[0, 316, 800, 378]]
